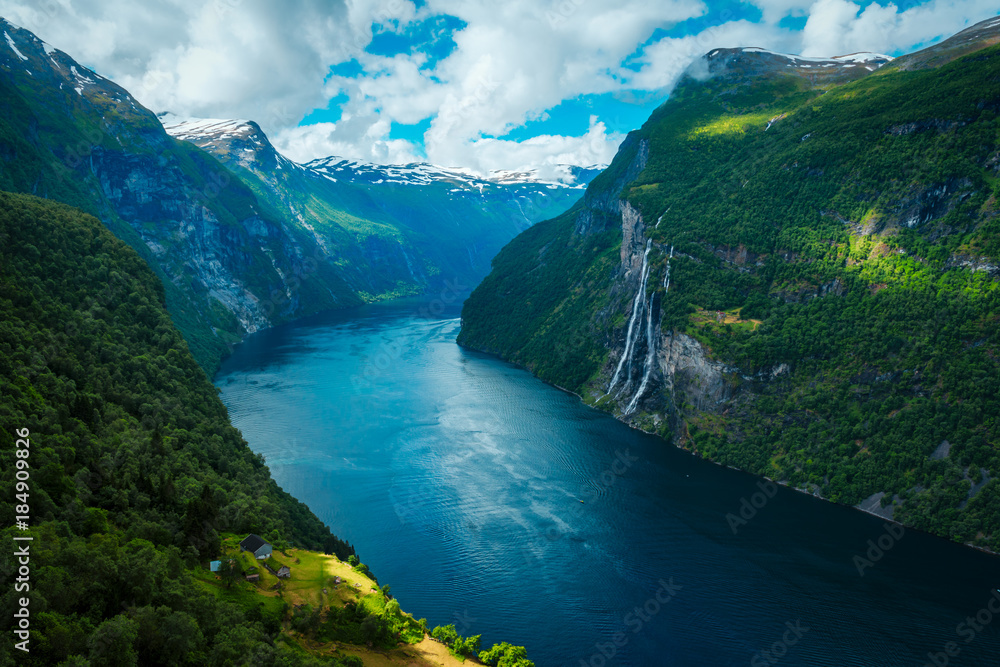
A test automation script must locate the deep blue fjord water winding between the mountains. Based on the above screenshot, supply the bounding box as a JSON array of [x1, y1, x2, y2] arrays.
[[215, 301, 1000, 667]]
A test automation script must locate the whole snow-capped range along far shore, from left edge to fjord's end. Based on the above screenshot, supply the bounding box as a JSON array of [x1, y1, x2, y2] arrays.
[[0, 19, 588, 374]]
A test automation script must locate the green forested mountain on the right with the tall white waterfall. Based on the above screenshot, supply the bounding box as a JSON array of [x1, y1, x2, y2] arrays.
[[459, 19, 1000, 551]]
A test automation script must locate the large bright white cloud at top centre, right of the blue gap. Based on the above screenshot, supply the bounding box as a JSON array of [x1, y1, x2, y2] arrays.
[[412, 0, 705, 167]]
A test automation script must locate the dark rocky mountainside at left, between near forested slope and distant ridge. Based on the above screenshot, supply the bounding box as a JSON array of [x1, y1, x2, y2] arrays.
[[0, 20, 361, 370]]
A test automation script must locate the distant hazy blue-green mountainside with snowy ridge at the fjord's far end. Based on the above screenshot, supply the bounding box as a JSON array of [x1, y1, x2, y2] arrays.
[[161, 114, 596, 298]]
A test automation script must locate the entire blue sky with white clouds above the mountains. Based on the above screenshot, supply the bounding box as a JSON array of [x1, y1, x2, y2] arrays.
[[0, 0, 1000, 176]]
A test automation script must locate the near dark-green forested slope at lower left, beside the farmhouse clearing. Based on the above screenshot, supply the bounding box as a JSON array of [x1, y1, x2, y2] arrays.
[[0, 193, 354, 665]]
